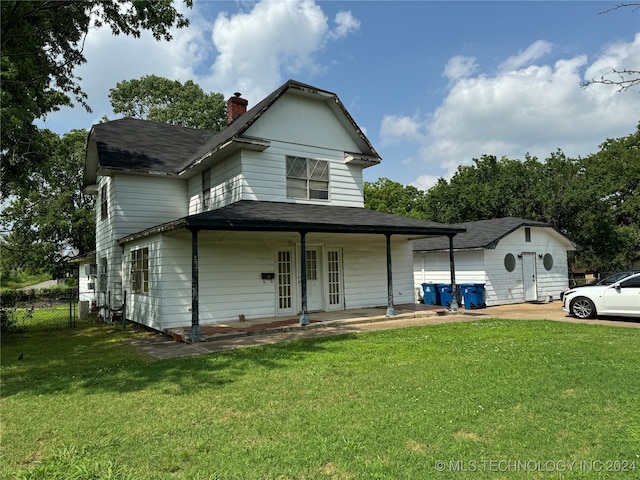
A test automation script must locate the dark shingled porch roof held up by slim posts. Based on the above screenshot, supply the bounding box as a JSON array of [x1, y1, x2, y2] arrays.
[[120, 200, 465, 244]]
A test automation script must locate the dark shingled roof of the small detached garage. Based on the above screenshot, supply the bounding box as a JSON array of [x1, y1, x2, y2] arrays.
[[413, 217, 579, 252]]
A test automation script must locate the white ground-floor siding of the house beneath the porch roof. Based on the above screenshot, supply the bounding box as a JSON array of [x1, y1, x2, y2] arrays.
[[130, 231, 414, 330]]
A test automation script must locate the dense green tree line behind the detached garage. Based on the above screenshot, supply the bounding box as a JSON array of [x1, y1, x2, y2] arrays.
[[364, 124, 640, 272]]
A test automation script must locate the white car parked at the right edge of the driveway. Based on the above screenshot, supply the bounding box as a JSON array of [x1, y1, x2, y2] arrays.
[[562, 273, 640, 320]]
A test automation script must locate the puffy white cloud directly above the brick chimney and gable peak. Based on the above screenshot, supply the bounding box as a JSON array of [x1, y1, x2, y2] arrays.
[[210, 0, 359, 99]]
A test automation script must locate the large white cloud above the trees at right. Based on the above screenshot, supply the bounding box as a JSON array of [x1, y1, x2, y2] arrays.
[[380, 34, 640, 188]]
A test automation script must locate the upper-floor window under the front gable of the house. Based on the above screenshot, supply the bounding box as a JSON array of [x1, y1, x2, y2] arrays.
[[287, 157, 329, 200]]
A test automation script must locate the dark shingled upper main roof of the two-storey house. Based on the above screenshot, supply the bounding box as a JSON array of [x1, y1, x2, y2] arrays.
[[84, 80, 380, 187]]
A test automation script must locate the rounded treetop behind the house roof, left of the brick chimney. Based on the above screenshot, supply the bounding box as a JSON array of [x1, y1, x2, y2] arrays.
[[109, 75, 227, 131]]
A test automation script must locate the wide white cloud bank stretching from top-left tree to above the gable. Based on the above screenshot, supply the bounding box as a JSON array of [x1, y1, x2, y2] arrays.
[[44, 0, 360, 133]]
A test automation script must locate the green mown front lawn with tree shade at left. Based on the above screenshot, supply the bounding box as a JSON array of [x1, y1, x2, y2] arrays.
[[0, 315, 640, 480]]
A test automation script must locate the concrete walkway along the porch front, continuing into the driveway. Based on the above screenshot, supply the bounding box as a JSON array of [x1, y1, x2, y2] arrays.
[[128, 302, 640, 359]]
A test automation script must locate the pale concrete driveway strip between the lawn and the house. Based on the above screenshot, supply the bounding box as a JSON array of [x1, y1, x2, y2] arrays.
[[128, 302, 640, 359]]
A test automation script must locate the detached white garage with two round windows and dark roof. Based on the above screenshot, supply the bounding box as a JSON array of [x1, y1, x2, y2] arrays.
[[413, 217, 579, 306]]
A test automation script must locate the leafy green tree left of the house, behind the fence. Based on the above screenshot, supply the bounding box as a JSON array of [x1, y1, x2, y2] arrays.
[[0, 130, 95, 276]]
